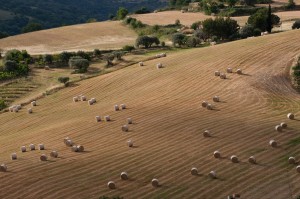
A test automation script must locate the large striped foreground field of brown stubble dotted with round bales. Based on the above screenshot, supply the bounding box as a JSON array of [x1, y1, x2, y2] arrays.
[[0, 30, 300, 199]]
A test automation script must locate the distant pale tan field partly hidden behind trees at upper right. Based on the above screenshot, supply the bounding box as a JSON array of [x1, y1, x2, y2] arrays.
[[132, 11, 300, 26]]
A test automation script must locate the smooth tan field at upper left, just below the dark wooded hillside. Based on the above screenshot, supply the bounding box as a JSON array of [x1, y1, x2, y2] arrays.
[[0, 21, 137, 54]]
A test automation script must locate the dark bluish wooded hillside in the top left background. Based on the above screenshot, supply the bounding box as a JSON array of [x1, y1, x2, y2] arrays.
[[0, 0, 167, 35]]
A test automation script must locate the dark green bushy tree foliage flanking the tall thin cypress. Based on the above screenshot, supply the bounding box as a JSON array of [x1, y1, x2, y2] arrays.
[[248, 8, 280, 31]]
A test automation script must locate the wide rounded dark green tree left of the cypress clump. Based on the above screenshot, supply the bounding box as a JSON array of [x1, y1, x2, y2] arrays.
[[202, 17, 239, 39]]
